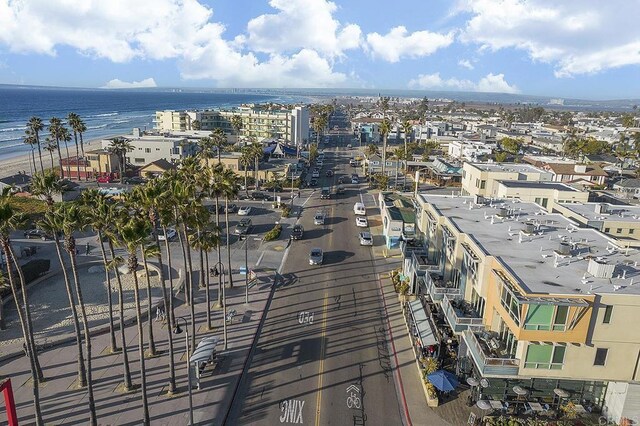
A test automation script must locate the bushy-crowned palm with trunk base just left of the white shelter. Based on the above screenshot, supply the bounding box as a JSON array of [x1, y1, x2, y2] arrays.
[[139, 179, 176, 394]]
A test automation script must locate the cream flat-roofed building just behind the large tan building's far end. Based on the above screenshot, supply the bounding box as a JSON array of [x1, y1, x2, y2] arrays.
[[462, 163, 552, 197]]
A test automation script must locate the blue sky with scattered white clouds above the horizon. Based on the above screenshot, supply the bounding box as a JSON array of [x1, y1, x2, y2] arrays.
[[0, 0, 640, 99]]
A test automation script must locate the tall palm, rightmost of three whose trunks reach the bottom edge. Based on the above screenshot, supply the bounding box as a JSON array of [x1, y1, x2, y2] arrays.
[[118, 215, 151, 426]]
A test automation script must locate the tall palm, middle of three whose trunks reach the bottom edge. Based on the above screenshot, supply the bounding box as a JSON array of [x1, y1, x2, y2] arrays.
[[54, 203, 98, 426]]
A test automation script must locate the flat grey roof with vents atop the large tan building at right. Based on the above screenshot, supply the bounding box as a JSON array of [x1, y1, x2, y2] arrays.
[[419, 193, 640, 295]]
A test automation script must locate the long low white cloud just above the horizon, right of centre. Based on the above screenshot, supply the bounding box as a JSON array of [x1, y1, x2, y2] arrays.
[[409, 73, 519, 93]]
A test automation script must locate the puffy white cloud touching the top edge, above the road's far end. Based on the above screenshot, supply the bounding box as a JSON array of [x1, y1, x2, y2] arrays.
[[243, 0, 362, 57]]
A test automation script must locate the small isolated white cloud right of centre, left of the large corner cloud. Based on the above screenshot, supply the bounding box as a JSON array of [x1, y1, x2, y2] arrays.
[[367, 26, 453, 63]]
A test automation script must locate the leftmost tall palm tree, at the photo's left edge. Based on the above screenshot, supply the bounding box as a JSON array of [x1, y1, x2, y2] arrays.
[[0, 187, 44, 426]]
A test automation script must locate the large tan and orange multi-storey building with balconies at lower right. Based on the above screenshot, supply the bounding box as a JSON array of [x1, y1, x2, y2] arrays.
[[403, 194, 640, 422]]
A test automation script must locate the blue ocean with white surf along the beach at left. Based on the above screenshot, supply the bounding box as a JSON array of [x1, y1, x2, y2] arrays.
[[0, 86, 317, 159]]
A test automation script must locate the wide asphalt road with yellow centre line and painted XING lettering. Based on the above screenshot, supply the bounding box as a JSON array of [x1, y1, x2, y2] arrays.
[[227, 135, 402, 425]]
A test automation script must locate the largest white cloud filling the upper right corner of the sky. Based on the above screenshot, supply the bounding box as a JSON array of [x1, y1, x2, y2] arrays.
[[456, 0, 640, 77]]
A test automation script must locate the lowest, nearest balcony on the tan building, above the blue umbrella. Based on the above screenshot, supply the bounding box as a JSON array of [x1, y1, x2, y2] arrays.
[[462, 329, 520, 377]]
